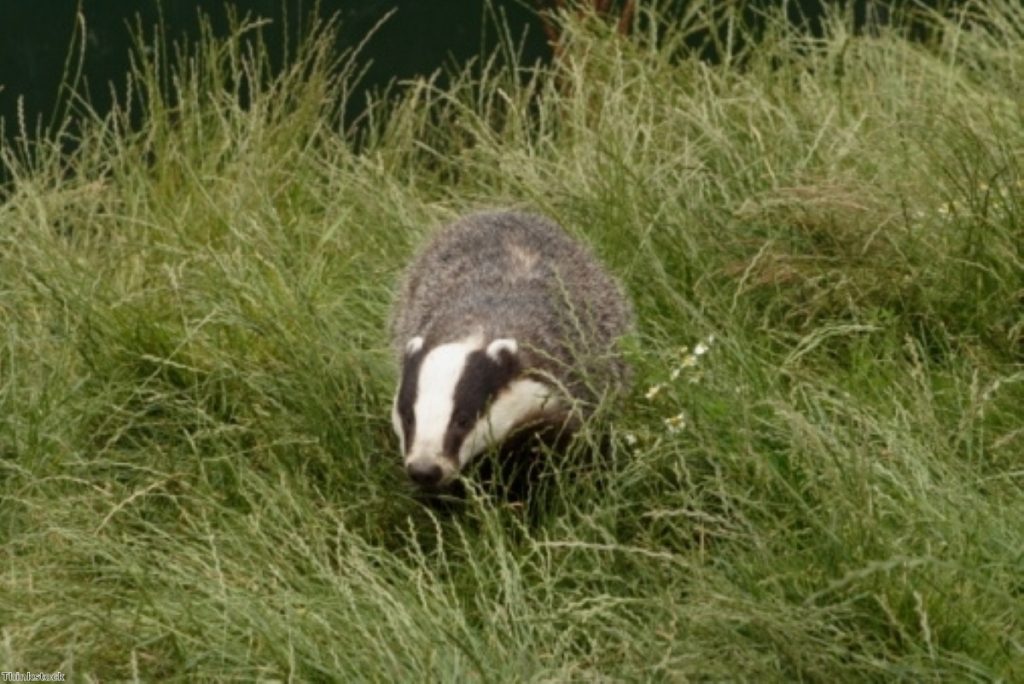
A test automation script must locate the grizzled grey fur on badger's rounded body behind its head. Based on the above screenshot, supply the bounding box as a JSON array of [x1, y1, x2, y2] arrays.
[[391, 211, 633, 411]]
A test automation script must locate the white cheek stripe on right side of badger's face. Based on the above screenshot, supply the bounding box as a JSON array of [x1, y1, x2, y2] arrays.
[[459, 378, 558, 469]]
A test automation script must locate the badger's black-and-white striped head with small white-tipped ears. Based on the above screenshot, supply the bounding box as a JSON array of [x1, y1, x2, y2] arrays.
[[391, 335, 557, 489]]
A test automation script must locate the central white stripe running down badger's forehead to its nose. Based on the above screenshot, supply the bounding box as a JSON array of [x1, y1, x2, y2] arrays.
[[406, 336, 483, 471]]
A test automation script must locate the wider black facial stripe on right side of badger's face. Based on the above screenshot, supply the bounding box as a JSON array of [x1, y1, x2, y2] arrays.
[[443, 350, 520, 458]]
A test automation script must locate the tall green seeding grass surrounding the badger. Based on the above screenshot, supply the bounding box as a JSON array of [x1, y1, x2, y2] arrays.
[[0, 0, 1024, 682]]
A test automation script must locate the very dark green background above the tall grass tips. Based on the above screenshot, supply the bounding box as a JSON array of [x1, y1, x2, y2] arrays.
[[0, 0, 954, 139]]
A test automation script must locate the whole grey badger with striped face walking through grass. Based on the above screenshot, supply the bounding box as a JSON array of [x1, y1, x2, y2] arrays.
[[391, 211, 633, 491]]
